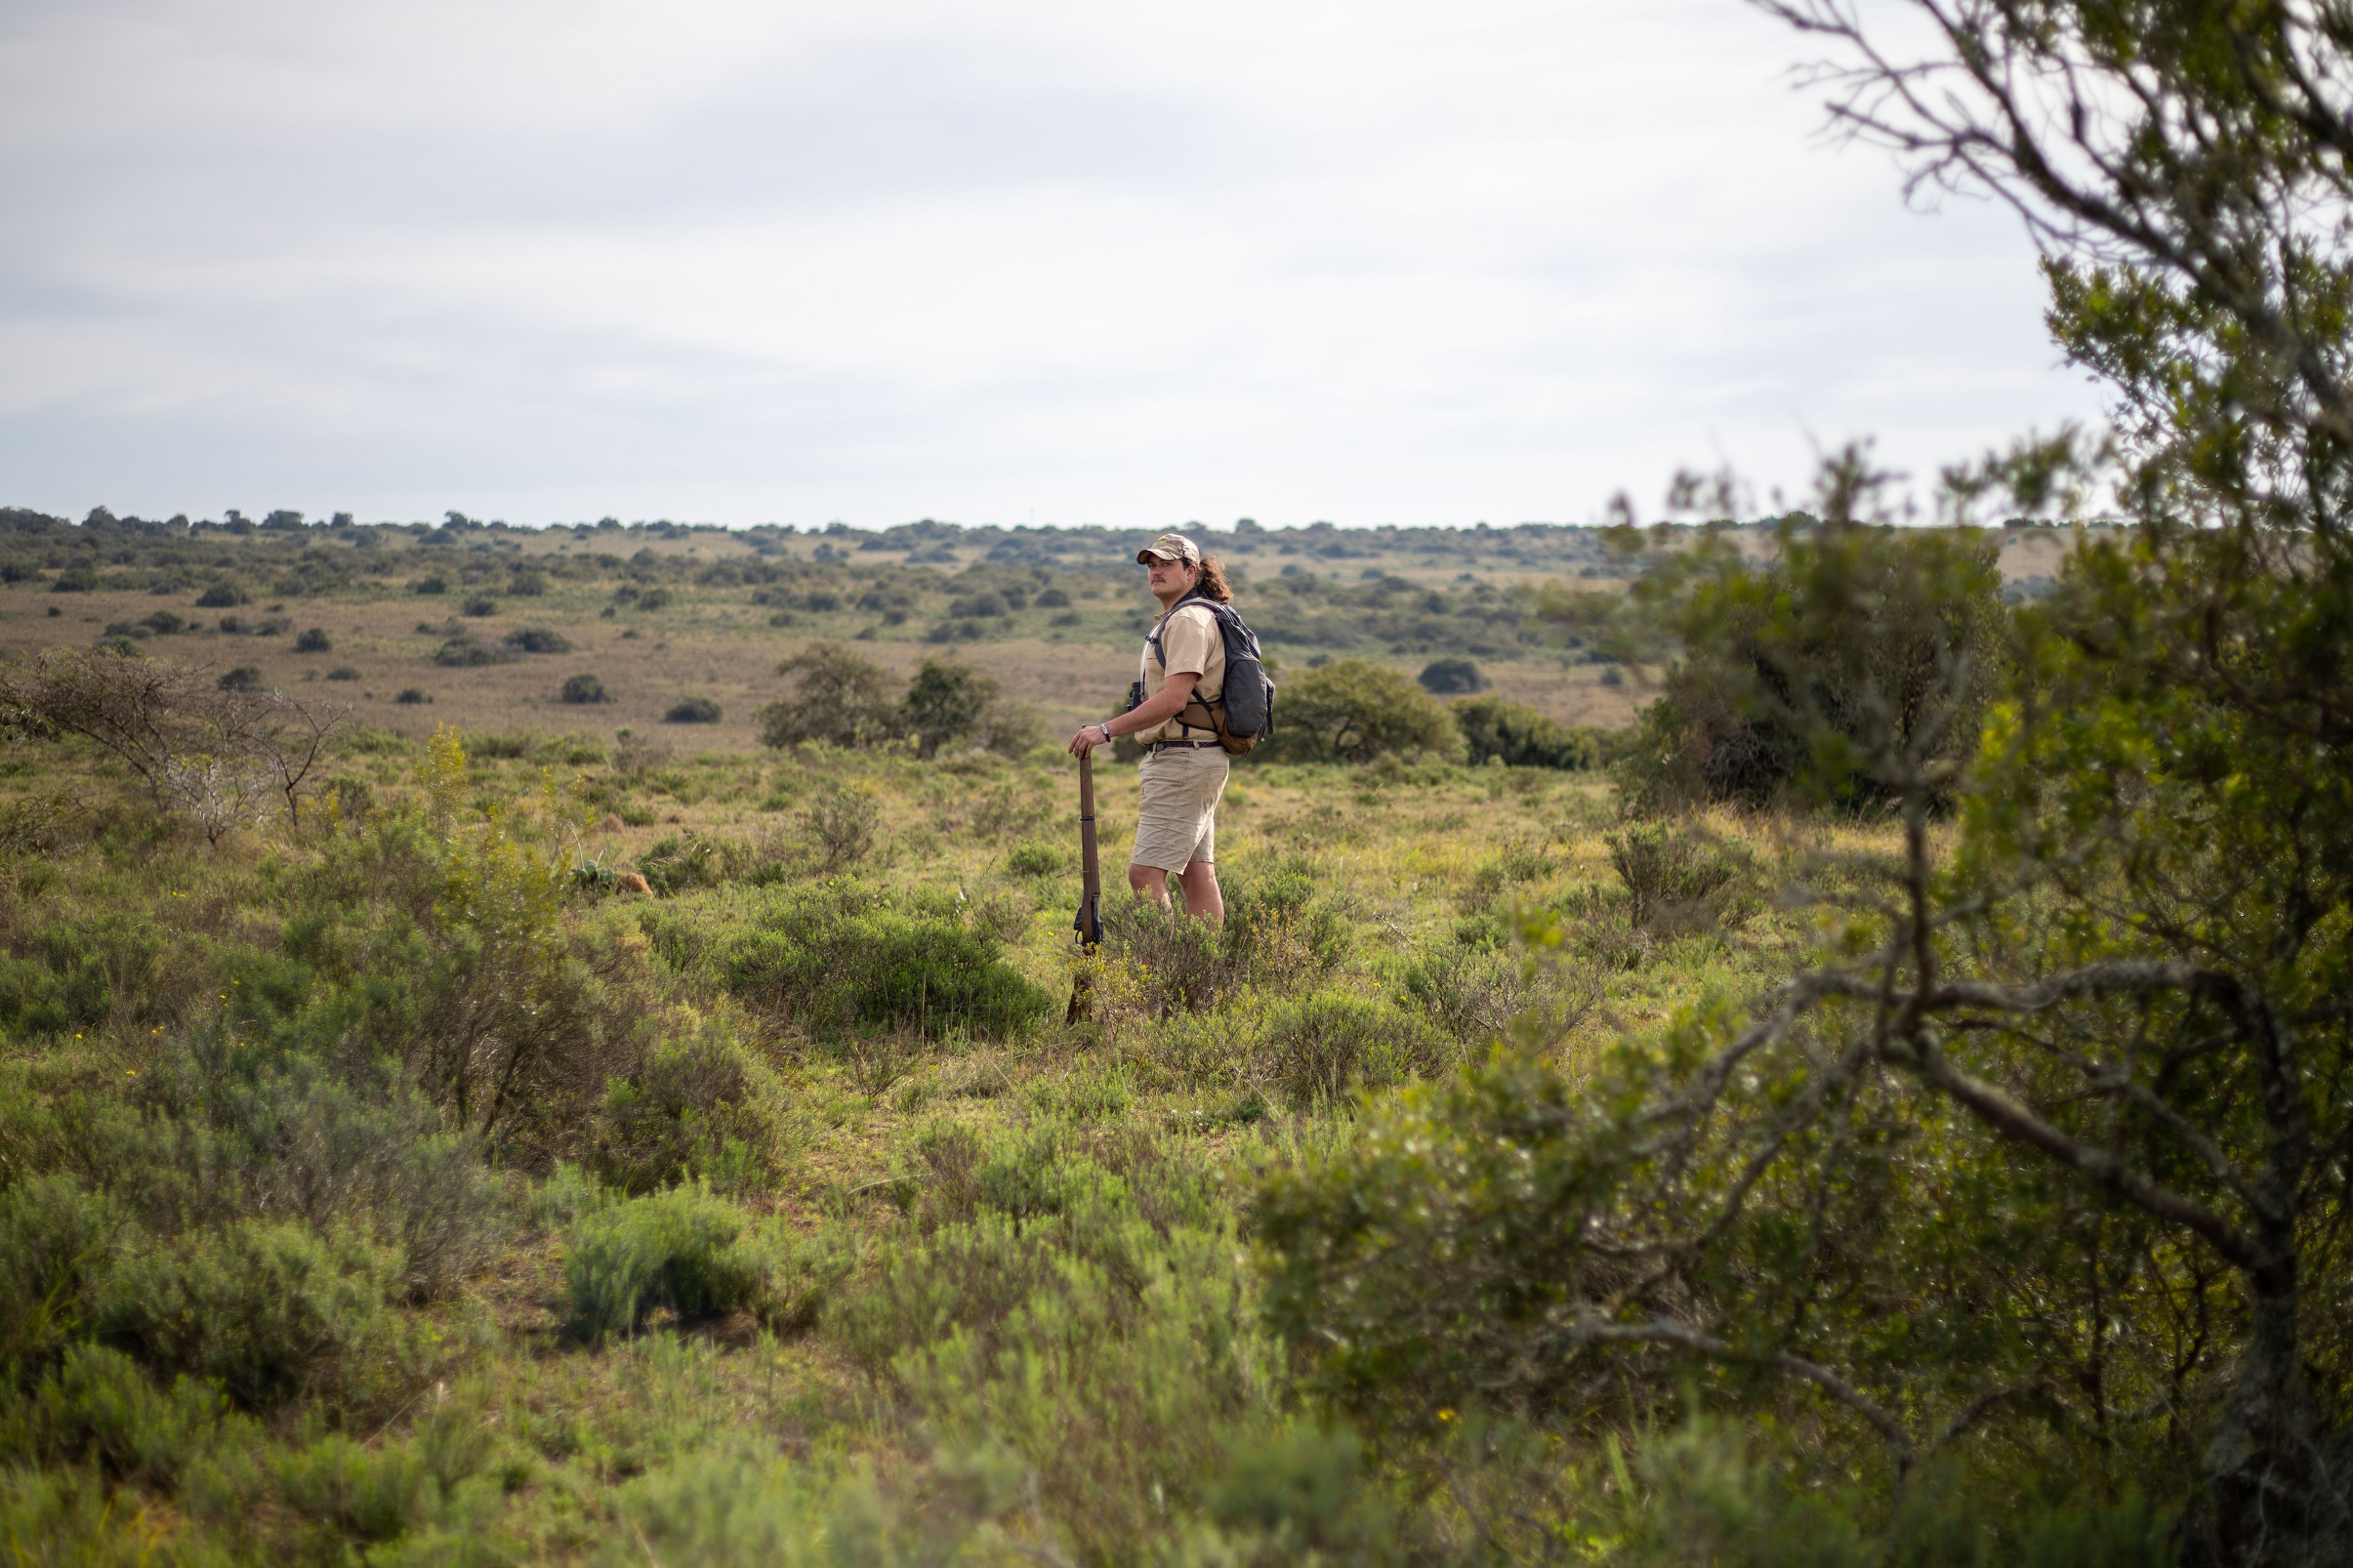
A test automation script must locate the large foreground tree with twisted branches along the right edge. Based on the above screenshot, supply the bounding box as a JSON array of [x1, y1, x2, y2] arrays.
[[1263, 0, 2353, 1566]]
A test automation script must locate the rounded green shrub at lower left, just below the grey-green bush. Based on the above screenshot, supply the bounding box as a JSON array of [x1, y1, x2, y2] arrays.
[[97, 1219, 407, 1410]]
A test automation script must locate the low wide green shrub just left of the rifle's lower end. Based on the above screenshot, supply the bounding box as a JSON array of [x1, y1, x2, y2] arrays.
[[722, 883, 1054, 1036]]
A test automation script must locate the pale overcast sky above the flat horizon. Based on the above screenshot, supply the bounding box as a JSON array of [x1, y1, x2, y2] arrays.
[[0, 0, 2096, 525]]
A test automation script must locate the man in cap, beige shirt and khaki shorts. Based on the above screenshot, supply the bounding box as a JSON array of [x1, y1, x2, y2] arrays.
[[1071, 534, 1233, 923]]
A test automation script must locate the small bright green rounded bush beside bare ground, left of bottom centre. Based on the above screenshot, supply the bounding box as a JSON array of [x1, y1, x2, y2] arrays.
[[564, 1186, 764, 1340]]
